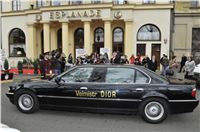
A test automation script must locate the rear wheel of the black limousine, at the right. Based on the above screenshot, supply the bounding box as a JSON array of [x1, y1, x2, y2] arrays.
[[139, 98, 169, 124]]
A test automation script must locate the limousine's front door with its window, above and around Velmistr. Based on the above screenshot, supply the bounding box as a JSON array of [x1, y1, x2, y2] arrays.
[[48, 67, 93, 108]]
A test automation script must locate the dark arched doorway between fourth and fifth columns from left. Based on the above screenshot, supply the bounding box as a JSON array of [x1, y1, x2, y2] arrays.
[[93, 27, 104, 54]]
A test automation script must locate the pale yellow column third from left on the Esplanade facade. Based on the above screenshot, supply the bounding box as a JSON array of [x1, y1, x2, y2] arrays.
[[62, 21, 70, 57]]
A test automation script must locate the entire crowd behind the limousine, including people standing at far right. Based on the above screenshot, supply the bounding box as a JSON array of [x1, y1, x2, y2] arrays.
[[40, 50, 195, 81]]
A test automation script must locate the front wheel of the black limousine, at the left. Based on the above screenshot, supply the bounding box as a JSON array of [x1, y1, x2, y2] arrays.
[[14, 90, 39, 114]]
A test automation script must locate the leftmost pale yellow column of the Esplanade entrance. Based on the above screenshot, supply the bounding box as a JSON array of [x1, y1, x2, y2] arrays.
[[26, 23, 38, 59]]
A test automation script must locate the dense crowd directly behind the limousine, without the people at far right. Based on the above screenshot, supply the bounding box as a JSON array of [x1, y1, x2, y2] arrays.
[[39, 49, 160, 78]]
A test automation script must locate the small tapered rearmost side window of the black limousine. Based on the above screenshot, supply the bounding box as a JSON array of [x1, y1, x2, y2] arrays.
[[135, 70, 149, 84]]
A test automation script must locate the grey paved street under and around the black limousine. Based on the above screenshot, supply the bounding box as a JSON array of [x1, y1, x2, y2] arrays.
[[1, 76, 200, 132]]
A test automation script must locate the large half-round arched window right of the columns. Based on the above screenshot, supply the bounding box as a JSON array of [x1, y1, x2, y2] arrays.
[[137, 24, 161, 41]]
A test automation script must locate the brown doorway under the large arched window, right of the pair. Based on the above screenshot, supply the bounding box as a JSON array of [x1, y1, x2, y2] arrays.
[[151, 44, 161, 69]]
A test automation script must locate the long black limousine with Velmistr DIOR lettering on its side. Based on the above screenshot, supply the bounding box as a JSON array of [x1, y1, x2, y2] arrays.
[[6, 65, 199, 123]]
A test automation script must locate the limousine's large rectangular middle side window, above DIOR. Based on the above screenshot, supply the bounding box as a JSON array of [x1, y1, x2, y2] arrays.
[[105, 68, 135, 83]]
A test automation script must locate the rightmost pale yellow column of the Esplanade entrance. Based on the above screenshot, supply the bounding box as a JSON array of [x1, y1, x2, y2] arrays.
[[124, 20, 134, 58]]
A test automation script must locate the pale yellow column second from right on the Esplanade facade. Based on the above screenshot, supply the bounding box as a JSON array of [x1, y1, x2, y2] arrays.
[[104, 20, 113, 58]]
